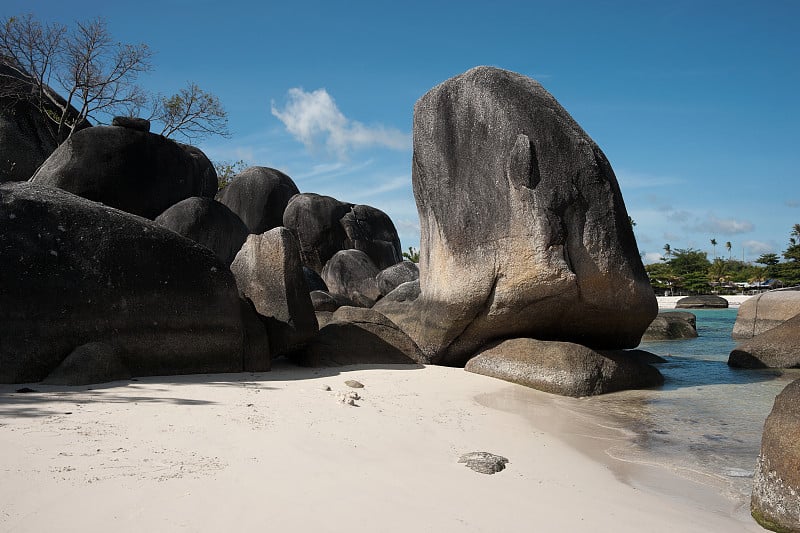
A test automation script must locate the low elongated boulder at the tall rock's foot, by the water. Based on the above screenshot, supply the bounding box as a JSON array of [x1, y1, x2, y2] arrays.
[[466, 339, 664, 397]]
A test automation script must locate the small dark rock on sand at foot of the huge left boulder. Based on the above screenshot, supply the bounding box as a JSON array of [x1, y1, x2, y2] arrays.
[[43, 342, 133, 386]]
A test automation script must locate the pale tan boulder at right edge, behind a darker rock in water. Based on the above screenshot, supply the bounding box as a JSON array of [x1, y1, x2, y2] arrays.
[[731, 287, 800, 339]]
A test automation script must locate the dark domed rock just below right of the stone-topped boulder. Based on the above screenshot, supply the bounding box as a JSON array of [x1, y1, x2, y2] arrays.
[[155, 196, 250, 266]]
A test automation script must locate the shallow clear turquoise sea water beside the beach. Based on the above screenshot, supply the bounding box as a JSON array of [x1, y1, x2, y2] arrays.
[[571, 308, 800, 502]]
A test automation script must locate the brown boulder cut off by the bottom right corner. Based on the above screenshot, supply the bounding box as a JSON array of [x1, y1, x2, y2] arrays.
[[750, 380, 800, 531]]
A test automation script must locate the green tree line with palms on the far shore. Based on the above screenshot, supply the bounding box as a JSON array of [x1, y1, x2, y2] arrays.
[[645, 224, 800, 294]]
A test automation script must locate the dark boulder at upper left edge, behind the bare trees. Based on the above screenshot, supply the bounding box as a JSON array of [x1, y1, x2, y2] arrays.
[[0, 58, 89, 182]]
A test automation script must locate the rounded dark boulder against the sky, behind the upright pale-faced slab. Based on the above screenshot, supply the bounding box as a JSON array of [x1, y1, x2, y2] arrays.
[[217, 167, 300, 233]]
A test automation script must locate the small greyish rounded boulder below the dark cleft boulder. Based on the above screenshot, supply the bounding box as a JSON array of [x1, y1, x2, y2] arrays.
[[322, 250, 381, 307]]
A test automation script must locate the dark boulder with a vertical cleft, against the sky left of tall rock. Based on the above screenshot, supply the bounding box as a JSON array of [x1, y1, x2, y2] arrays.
[[283, 193, 403, 274]]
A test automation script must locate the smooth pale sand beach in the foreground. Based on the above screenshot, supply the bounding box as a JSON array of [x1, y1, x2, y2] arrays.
[[0, 365, 762, 533]]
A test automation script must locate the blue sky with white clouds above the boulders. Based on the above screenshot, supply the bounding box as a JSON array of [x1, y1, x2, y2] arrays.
[[7, 0, 800, 263]]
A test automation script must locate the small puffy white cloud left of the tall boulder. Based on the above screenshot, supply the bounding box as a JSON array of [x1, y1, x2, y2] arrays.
[[272, 87, 411, 159]]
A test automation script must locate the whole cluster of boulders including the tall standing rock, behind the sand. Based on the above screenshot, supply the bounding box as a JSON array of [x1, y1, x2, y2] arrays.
[[0, 67, 662, 396]]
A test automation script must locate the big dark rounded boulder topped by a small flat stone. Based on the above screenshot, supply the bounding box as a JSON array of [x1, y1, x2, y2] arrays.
[[31, 126, 217, 219]]
